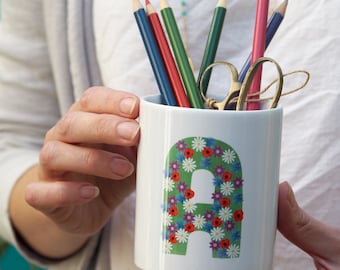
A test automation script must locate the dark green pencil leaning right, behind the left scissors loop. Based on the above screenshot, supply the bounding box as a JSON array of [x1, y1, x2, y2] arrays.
[[197, 0, 227, 94]]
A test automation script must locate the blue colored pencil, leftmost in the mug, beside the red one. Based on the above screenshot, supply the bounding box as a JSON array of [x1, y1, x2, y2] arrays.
[[132, 0, 177, 106]]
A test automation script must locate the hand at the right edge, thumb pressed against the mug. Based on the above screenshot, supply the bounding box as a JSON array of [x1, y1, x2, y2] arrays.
[[278, 182, 340, 270]]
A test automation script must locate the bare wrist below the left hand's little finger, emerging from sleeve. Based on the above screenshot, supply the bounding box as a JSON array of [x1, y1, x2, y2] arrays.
[[9, 166, 88, 259]]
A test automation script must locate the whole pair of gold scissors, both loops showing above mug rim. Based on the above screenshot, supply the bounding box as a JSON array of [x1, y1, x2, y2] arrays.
[[199, 57, 284, 111]]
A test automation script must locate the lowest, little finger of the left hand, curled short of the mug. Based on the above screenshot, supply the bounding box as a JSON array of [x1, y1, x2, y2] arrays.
[[25, 181, 99, 213]]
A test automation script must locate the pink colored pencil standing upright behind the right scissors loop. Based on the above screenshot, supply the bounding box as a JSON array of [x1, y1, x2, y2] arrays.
[[247, 0, 269, 110]]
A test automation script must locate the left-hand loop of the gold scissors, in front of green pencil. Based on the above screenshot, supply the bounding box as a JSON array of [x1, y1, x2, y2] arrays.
[[200, 62, 241, 110]]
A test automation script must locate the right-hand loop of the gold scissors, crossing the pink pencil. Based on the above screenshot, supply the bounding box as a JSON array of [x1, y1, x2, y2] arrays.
[[236, 57, 283, 111]]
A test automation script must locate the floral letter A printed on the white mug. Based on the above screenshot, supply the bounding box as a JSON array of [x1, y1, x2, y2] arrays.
[[163, 137, 243, 258]]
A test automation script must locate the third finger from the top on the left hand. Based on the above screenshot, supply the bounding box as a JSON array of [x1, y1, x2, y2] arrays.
[[40, 141, 134, 179]]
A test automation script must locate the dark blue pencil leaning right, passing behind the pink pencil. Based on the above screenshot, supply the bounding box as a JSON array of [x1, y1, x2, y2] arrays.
[[239, 0, 288, 83]]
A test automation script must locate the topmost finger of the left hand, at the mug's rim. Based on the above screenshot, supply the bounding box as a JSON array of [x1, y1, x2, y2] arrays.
[[71, 87, 139, 118]]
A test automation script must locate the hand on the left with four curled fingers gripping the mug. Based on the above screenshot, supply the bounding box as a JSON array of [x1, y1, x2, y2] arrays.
[[25, 87, 139, 243]]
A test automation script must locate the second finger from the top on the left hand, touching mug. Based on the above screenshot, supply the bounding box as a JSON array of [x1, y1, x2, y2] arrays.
[[46, 111, 139, 146]]
